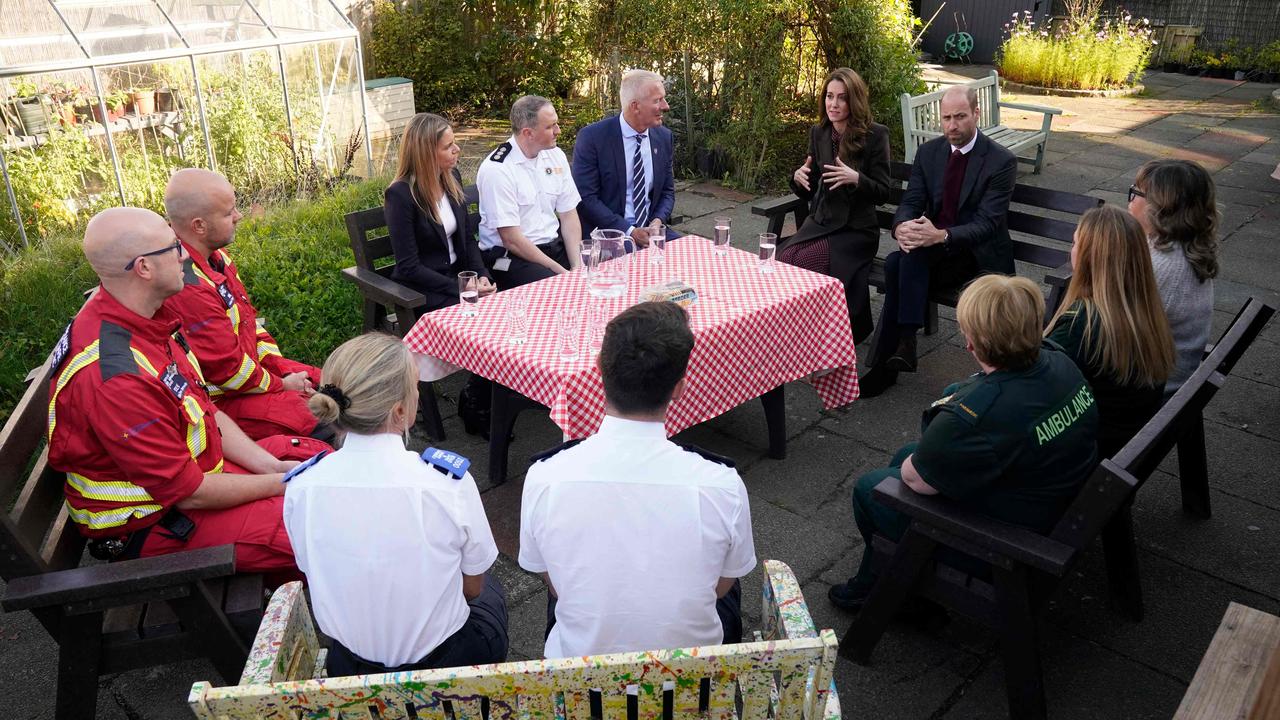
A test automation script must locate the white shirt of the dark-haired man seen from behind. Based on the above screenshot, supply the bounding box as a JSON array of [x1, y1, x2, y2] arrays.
[[520, 415, 755, 657]]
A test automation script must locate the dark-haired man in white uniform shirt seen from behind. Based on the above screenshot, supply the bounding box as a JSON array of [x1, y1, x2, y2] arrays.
[[520, 302, 755, 657]]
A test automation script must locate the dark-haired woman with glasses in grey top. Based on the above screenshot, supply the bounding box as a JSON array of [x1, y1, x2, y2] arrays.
[[1129, 160, 1219, 397]]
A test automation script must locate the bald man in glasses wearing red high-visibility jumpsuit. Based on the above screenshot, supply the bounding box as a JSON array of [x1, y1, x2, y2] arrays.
[[49, 208, 329, 579]]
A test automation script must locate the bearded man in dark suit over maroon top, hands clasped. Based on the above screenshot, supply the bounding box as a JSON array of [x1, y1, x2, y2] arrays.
[[861, 85, 1018, 397]]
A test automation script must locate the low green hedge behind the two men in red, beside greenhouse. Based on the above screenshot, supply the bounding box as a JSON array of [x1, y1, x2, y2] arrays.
[[0, 179, 387, 423]]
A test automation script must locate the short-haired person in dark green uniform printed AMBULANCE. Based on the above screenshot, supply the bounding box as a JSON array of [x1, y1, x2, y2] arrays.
[[828, 275, 1098, 611]]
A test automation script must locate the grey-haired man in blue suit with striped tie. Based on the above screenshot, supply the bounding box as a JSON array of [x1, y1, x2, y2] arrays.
[[573, 70, 677, 247]]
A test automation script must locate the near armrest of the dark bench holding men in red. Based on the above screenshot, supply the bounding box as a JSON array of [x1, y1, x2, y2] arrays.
[[0, 544, 236, 611]]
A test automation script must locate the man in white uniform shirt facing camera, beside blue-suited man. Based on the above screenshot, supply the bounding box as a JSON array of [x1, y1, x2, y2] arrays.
[[476, 95, 582, 288]]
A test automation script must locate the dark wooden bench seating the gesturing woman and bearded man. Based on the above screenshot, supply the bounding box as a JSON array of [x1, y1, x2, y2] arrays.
[[751, 161, 1102, 334]]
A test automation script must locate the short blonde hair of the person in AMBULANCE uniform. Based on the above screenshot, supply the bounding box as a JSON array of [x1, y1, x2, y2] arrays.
[[956, 275, 1044, 370]]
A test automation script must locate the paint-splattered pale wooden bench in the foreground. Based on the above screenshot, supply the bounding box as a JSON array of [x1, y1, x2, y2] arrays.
[[189, 560, 840, 720]]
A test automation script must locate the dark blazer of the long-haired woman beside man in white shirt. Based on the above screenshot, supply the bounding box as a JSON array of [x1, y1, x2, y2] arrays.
[[383, 169, 492, 309]]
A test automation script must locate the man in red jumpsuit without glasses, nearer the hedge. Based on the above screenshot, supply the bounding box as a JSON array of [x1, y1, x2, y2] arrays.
[[165, 169, 332, 438]]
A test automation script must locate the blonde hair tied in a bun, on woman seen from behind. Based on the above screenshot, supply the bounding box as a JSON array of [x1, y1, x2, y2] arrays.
[[307, 333, 417, 434]]
